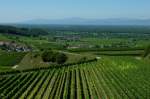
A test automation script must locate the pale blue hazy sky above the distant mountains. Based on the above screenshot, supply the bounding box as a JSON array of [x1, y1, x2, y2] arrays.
[[0, 0, 150, 22]]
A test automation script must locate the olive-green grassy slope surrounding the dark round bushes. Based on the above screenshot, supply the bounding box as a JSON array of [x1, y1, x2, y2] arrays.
[[16, 51, 95, 70]]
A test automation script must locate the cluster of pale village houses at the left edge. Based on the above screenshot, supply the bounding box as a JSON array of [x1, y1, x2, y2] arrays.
[[0, 41, 32, 52]]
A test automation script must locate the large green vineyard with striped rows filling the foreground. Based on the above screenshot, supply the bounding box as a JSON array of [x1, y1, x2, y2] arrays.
[[0, 57, 150, 99]]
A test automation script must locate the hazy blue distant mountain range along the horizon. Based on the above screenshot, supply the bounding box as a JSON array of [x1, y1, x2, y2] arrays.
[[20, 18, 150, 25]]
